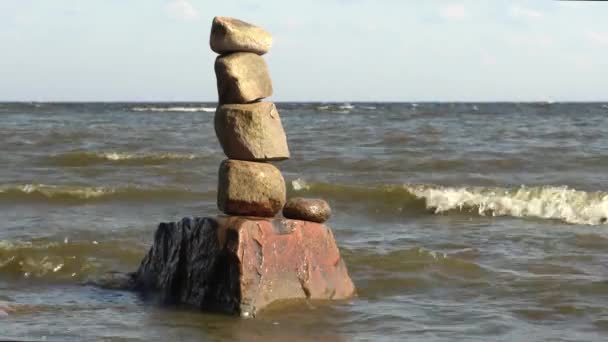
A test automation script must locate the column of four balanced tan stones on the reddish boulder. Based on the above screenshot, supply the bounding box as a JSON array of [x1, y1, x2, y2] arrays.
[[210, 17, 289, 217]]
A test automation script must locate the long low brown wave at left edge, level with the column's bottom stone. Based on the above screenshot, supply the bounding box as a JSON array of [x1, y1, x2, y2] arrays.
[[0, 184, 212, 204]]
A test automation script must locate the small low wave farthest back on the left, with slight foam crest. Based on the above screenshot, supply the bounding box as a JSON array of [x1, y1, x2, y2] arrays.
[[47, 152, 199, 166]]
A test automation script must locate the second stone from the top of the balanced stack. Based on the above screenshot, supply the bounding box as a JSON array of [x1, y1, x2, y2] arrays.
[[215, 52, 272, 104]]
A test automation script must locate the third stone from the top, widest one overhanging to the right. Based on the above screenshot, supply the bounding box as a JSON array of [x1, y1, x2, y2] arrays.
[[215, 102, 289, 161]]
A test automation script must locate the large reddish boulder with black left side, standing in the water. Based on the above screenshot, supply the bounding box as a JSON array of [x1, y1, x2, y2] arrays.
[[134, 216, 355, 317]]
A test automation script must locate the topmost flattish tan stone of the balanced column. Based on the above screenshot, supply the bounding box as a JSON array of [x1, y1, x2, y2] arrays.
[[209, 17, 272, 56]]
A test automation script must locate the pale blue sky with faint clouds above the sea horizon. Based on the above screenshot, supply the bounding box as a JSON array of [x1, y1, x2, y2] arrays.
[[0, 0, 608, 101]]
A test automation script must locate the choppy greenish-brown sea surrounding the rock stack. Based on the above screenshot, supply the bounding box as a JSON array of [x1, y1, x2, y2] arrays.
[[0, 103, 608, 342]]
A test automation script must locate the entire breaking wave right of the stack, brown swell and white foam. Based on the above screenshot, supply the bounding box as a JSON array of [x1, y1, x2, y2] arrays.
[[291, 179, 608, 225]]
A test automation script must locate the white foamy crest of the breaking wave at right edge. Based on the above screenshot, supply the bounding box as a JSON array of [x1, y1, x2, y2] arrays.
[[405, 185, 608, 225]]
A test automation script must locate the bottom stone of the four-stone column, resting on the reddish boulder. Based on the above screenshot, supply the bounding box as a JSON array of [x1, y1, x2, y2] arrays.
[[217, 159, 286, 217]]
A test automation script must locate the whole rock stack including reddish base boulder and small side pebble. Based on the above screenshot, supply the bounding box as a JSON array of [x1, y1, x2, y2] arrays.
[[132, 17, 355, 317]]
